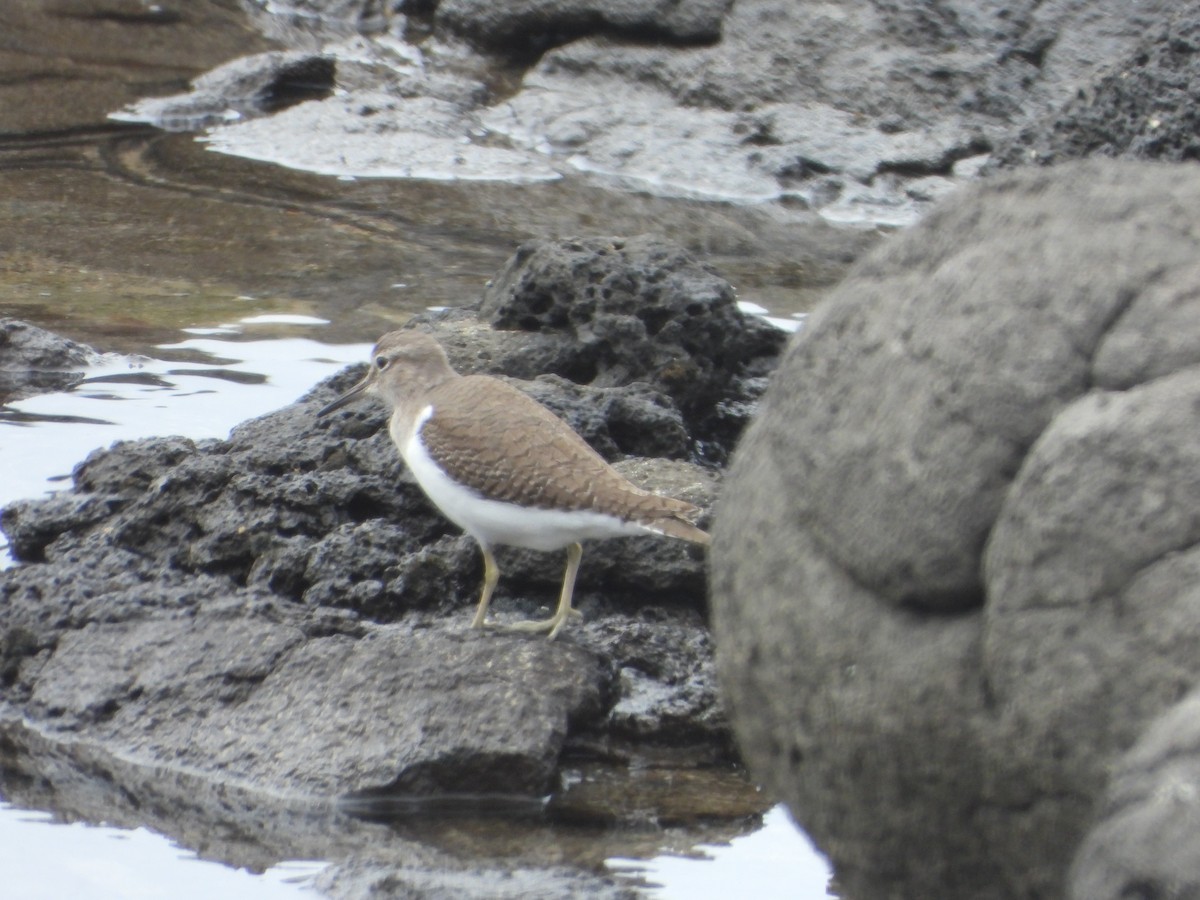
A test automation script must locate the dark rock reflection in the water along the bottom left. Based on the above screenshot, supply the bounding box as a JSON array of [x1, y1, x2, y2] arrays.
[[0, 718, 748, 900]]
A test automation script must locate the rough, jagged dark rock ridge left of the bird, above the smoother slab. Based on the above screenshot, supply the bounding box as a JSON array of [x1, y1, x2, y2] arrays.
[[0, 355, 712, 619]]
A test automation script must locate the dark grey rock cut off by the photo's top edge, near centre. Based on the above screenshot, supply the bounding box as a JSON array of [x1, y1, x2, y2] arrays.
[[434, 0, 733, 55]]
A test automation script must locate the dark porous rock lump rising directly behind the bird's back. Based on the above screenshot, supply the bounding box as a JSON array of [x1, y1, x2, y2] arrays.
[[479, 235, 784, 462]]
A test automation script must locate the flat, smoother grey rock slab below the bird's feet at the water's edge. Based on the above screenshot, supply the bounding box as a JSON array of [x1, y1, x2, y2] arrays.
[[0, 427, 676, 796]]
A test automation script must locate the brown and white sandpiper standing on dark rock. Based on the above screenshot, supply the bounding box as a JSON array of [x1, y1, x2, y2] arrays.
[[317, 330, 709, 640]]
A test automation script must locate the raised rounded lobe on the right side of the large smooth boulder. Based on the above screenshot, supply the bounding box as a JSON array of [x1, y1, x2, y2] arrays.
[[983, 369, 1200, 800]]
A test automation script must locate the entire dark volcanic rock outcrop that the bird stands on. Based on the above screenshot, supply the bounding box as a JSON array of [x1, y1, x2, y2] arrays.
[[0, 232, 784, 897]]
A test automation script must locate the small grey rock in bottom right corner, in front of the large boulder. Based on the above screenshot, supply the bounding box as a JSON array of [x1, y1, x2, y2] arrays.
[[1070, 686, 1200, 900]]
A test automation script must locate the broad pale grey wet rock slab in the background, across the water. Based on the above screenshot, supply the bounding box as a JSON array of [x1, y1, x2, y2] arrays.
[[470, 0, 1175, 223]]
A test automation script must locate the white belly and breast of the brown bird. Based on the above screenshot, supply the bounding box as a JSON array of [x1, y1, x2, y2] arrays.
[[391, 407, 646, 551]]
